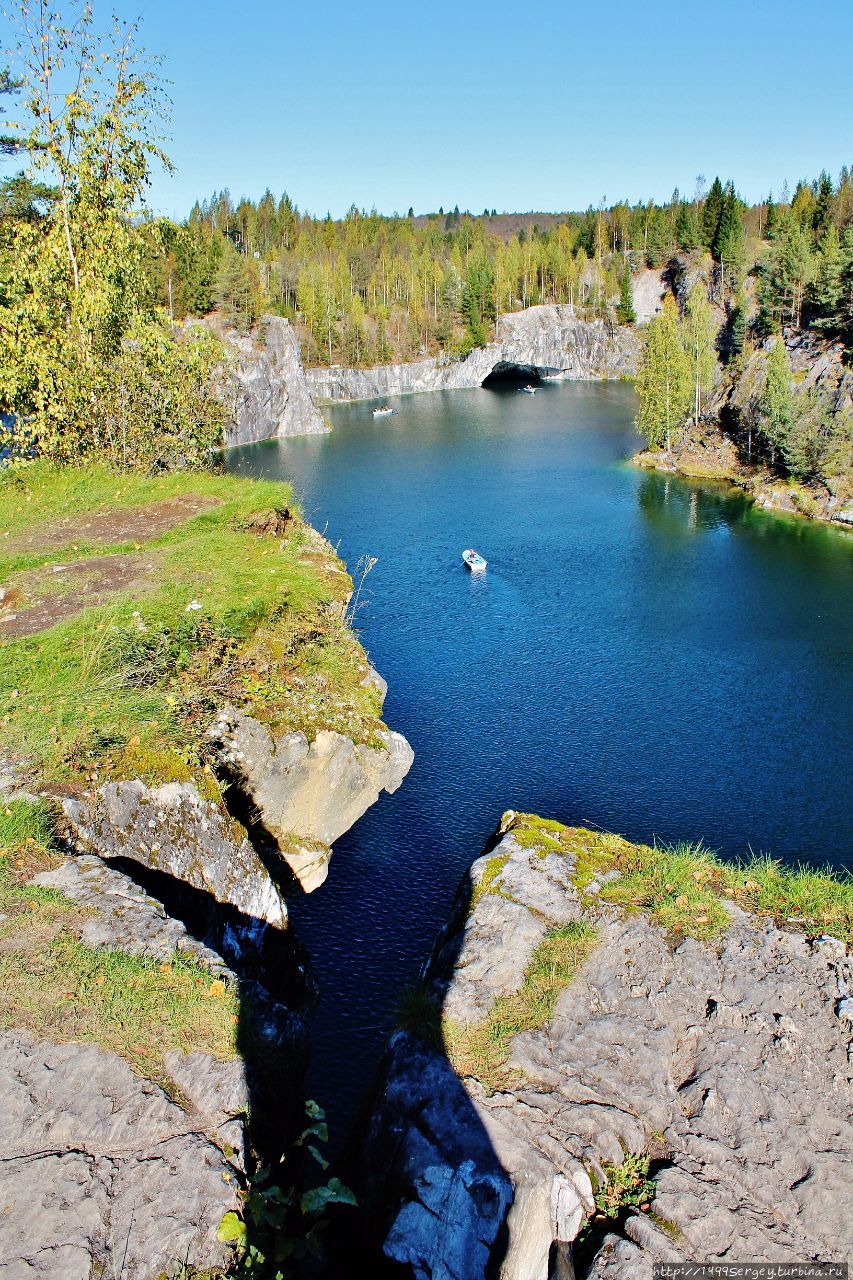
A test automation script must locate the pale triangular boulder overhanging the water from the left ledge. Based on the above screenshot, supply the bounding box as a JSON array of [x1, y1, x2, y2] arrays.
[[209, 701, 414, 892]]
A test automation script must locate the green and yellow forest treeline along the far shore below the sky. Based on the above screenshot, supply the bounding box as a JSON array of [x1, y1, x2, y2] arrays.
[[144, 169, 853, 365]]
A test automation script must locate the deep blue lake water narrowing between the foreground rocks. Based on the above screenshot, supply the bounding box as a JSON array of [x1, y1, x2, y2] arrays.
[[229, 383, 853, 1133]]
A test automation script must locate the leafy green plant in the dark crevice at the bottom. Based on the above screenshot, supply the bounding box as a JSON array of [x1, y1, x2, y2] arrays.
[[219, 1101, 356, 1280]]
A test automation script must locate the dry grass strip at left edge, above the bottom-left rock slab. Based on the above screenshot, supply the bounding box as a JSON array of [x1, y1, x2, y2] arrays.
[[0, 800, 238, 1079]]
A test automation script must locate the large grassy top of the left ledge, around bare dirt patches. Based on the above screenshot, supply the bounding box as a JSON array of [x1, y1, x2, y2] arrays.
[[0, 466, 383, 782]]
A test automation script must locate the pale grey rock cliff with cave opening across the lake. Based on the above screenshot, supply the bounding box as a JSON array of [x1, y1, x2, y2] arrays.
[[306, 306, 639, 401]]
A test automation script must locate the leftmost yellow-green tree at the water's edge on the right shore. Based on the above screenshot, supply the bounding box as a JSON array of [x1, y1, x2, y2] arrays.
[[637, 294, 693, 453]]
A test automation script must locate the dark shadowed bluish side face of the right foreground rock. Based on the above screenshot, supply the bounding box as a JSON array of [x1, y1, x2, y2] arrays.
[[316, 835, 575, 1280]]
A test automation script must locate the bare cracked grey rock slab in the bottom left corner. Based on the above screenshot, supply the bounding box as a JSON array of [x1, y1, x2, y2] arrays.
[[0, 1030, 246, 1280]]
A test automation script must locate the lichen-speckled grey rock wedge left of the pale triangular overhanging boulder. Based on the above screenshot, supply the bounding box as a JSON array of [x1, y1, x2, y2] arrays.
[[63, 780, 287, 928]]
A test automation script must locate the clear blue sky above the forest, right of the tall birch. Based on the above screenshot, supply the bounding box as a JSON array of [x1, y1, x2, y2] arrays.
[[39, 0, 853, 216]]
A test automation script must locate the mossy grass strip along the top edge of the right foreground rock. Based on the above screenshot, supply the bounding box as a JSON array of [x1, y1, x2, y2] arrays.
[[511, 814, 853, 945]]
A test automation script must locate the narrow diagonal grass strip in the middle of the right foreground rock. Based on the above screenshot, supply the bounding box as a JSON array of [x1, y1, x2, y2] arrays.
[[444, 920, 596, 1092]]
